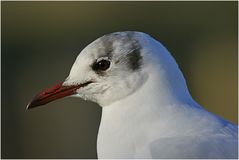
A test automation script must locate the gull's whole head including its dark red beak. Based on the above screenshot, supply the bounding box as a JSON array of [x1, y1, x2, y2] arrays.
[[27, 31, 189, 108]]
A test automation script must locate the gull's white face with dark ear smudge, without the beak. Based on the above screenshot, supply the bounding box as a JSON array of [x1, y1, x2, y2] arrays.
[[63, 32, 149, 106]]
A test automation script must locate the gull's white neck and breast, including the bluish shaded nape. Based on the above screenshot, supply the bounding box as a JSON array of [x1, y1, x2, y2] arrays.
[[97, 37, 220, 158]]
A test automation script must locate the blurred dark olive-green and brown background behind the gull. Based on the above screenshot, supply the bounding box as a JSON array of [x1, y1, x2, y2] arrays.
[[1, 1, 238, 158]]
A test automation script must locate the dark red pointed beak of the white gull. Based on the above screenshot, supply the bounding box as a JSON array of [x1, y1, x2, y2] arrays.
[[27, 82, 91, 109]]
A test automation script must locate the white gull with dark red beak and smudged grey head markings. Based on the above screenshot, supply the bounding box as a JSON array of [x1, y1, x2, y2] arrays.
[[27, 31, 238, 159]]
